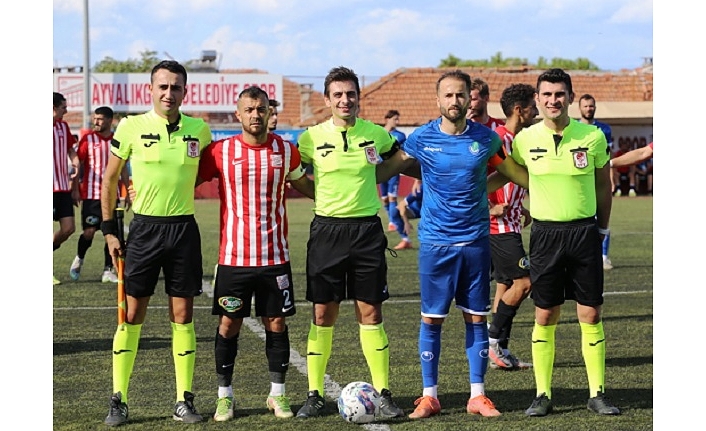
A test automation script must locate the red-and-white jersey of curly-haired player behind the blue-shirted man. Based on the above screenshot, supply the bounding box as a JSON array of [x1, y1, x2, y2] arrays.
[[488, 125, 526, 235]]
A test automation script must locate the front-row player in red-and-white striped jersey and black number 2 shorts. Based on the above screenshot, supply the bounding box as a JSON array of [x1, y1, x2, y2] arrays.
[[194, 86, 314, 422]]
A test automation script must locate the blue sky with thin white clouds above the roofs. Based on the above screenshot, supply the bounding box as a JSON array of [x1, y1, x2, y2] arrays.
[[52, 0, 653, 86]]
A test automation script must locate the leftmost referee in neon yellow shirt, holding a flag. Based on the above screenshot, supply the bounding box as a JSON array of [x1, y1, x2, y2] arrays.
[[101, 60, 211, 426]]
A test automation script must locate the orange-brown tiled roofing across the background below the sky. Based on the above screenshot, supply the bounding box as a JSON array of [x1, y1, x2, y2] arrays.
[[64, 67, 653, 129]]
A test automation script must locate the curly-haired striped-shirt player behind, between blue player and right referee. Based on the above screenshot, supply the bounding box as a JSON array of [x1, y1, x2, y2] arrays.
[[488, 84, 539, 370]]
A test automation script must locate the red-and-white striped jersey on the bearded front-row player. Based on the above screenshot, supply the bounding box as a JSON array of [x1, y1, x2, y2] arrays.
[[199, 133, 304, 267]]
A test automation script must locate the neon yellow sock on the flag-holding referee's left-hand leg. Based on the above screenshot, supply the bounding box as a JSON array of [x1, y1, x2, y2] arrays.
[[113, 323, 142, 403]]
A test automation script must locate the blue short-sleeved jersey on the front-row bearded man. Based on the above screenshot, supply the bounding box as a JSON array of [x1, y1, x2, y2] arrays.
[[402, 117, 505, 245]]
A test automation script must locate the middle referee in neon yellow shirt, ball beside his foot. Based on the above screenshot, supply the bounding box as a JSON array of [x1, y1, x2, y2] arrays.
[[297, 66, 404, 418]]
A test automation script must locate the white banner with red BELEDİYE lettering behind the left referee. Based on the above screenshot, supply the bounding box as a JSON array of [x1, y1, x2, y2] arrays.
[[54, 73, 284, 113]]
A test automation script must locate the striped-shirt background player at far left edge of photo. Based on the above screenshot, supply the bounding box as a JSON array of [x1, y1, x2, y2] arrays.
[[53, 91, 79, 285]]
